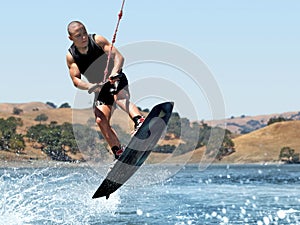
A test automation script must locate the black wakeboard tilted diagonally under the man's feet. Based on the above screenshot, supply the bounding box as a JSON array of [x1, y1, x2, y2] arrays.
[[92, 102, 174, 199]]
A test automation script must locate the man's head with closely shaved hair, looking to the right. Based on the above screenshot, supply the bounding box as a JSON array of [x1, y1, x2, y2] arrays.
[[69, 24, 88, 48]]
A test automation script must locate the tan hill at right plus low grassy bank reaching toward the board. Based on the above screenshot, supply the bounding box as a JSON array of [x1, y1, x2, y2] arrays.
[[159, 121, 300, 164]]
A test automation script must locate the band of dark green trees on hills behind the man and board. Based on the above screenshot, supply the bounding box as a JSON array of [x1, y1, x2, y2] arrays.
[[0, 112, 234, 161]]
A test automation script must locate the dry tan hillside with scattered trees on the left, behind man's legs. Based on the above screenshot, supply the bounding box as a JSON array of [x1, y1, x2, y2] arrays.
[[0, 102, 142, 165]]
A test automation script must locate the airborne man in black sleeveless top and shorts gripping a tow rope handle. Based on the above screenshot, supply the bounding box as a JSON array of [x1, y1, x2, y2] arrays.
[[66, 21, 144, 159]]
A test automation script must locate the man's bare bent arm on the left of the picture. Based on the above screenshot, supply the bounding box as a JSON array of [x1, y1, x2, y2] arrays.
[[67, 52, 93, 90]]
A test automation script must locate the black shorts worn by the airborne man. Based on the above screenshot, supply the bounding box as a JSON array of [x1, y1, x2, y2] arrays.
[[95, 73, 129, 106]]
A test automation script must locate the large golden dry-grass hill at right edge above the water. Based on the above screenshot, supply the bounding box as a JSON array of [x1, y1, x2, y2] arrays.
[[222, 121, 300, 163]]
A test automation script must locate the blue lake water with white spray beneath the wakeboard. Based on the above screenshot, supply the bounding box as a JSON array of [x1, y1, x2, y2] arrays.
[[0, 165, 300, 225]]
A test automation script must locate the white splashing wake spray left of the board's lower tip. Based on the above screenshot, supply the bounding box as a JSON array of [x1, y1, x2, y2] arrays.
[[0, 168, 120, 224]]
